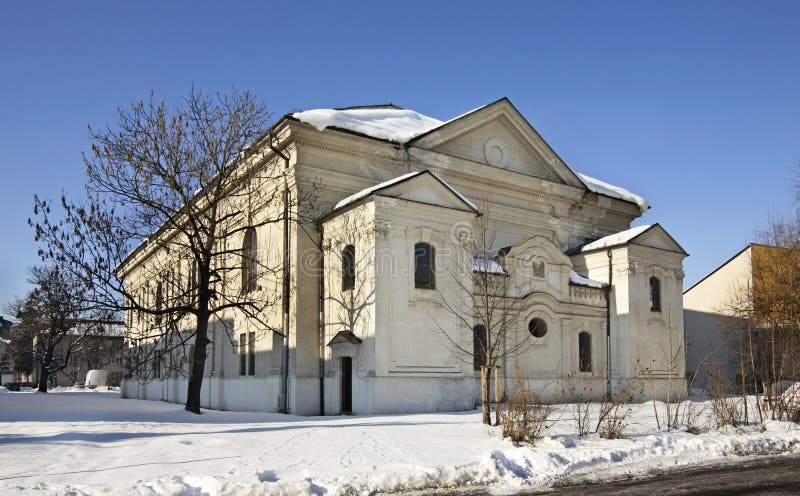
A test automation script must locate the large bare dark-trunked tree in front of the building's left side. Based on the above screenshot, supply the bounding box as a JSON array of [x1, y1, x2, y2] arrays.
[[31, 90, 306, 413]]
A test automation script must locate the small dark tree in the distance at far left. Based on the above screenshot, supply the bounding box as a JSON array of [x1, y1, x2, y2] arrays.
[[11, 267, 112, 393]]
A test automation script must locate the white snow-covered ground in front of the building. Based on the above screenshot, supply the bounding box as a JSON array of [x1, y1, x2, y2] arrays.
[[0, 389, 800, 496]]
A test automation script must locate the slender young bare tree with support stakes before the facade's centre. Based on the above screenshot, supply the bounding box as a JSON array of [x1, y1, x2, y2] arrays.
[[439, 209, 530, 424]]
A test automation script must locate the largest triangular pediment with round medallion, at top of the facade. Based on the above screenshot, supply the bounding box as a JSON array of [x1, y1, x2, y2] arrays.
[[408, 98, 584, 188]]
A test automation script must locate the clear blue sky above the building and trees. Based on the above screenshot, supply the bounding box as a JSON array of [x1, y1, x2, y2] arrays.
[[0, 0, 800, 313]]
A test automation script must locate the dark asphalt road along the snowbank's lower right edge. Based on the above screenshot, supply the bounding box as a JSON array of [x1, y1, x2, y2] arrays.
[[407, 455, 800, 496]]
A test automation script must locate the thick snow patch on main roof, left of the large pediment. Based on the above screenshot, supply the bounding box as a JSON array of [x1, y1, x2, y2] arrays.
[[292, 107, 444, 143]]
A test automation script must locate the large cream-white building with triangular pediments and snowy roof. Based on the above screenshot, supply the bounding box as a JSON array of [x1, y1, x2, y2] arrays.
[[122, 98, 686, 415]]
